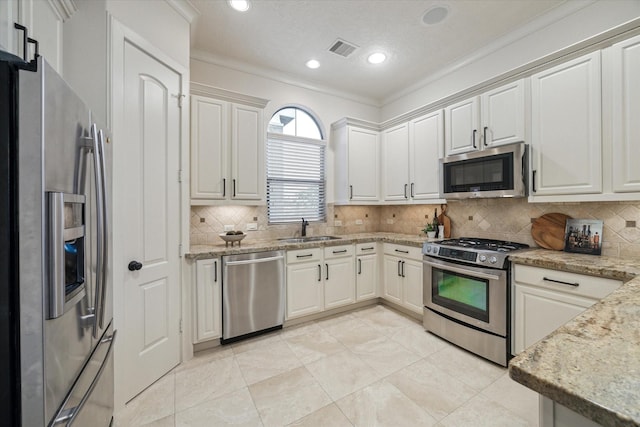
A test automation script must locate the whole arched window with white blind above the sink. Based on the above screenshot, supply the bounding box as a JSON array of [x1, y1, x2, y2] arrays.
[[267, 107, 326, 223]]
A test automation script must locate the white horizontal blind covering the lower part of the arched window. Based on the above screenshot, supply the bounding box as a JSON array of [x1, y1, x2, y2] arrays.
[[267, 135, 326, 223]]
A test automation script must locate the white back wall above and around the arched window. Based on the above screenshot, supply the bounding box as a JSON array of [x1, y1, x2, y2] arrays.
[[190, 58, 380, 203]]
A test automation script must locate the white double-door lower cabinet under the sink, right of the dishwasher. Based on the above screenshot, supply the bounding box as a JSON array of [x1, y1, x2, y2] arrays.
[[287, 245, 356, 319]]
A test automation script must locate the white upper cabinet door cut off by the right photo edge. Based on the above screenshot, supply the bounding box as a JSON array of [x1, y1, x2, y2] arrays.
[[611, 36, 640, 192]]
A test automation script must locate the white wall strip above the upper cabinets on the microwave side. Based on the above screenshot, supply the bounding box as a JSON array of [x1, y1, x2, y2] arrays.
[[381, 0, 640, 121]]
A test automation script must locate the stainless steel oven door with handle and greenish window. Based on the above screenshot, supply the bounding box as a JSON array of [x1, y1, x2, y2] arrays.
[[423, 256, 507, 336]]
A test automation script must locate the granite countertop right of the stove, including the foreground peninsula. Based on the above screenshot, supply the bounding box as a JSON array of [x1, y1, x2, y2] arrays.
[[509, 249, 640, 426]]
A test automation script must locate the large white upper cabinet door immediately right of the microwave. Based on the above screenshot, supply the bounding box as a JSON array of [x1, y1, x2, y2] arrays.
[[531, 52, 602, 195]]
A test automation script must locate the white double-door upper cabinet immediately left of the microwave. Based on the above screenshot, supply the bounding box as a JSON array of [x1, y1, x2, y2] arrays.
[[382, 110, 443, 203]]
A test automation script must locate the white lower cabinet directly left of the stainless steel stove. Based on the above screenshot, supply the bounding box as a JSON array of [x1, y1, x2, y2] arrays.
[[382, 243, 423, 314]]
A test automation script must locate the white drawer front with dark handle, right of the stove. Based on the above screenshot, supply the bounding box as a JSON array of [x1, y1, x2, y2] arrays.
[[513, 264, 622, 299]]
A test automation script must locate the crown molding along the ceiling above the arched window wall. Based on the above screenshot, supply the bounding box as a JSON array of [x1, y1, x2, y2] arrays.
[[191, 49, 382, 108]]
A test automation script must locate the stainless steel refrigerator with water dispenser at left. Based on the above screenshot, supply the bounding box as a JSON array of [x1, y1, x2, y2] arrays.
[[0, 52, 116, 427]]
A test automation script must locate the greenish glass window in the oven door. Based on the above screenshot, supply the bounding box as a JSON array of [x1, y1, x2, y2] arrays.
[[431, 267, 489, 323]]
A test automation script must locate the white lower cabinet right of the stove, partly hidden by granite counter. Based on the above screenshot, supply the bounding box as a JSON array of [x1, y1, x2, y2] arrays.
[[511, 264, 622, 354]]
